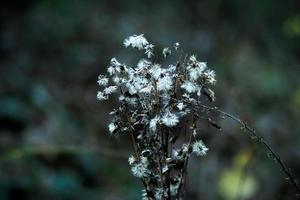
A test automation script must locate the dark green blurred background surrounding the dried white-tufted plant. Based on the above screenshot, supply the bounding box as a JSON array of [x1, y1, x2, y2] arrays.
[[0, 0, 300, 200]]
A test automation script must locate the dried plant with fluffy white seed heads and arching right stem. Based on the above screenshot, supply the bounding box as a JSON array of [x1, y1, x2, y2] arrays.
[[97, 35, 300, 199]]
